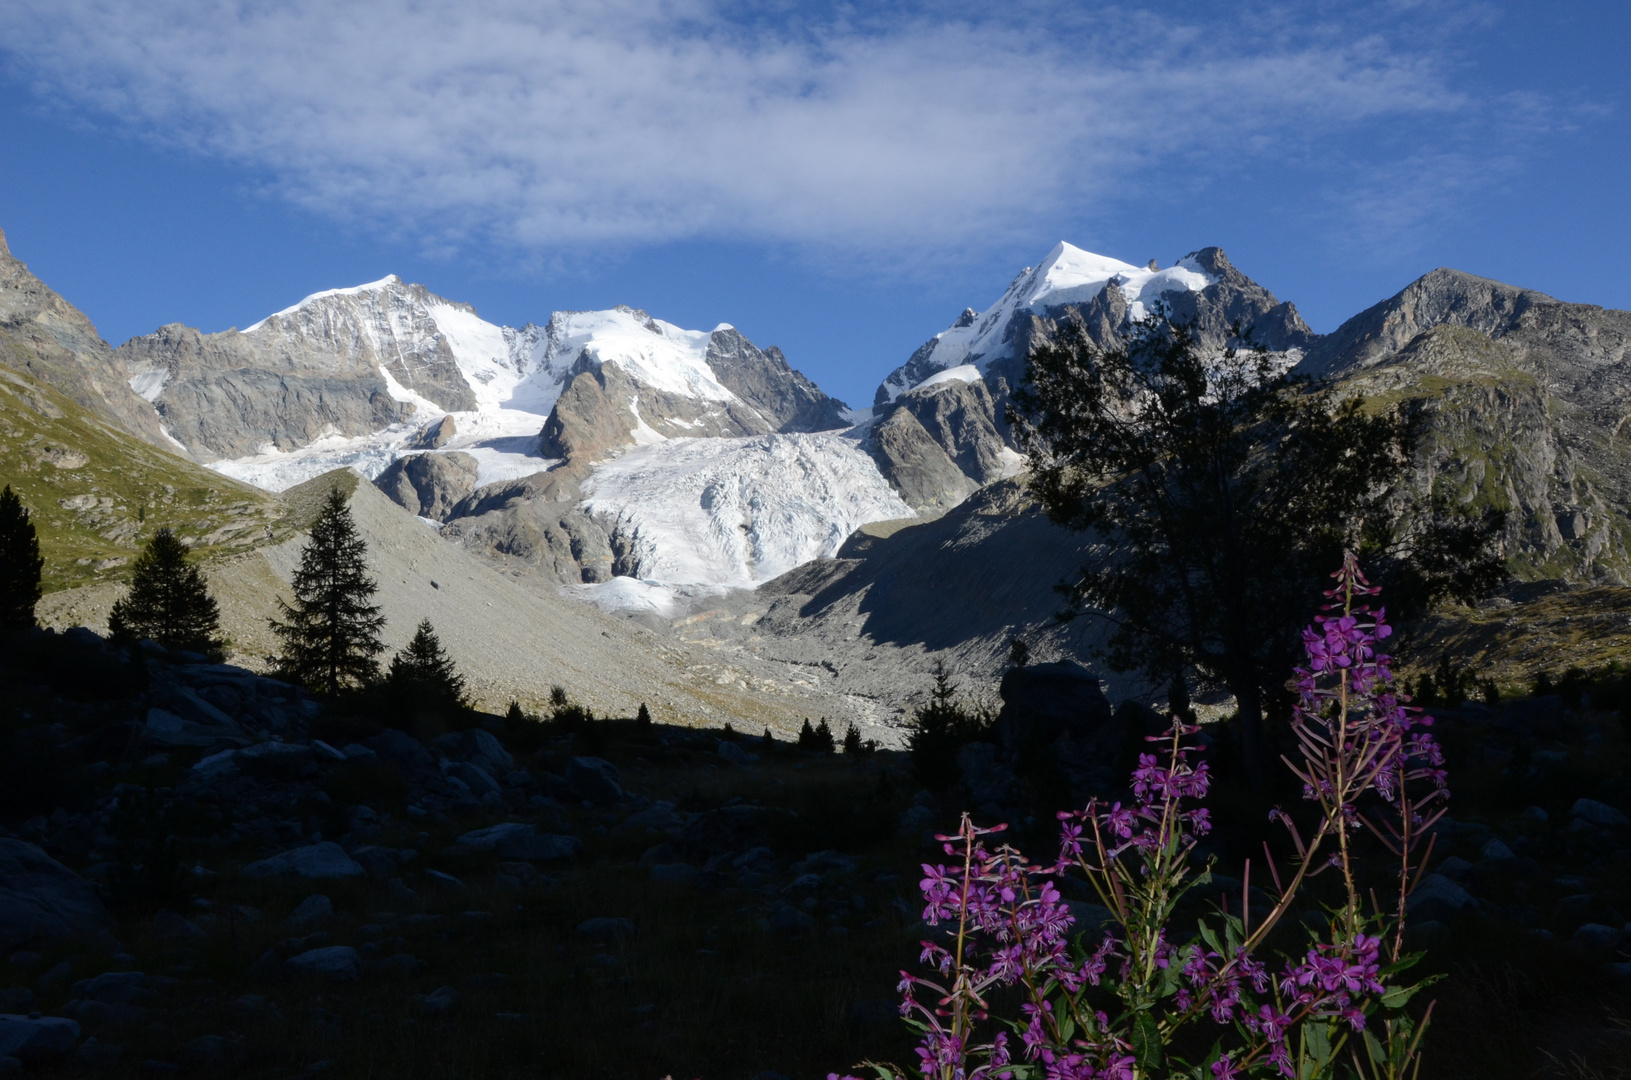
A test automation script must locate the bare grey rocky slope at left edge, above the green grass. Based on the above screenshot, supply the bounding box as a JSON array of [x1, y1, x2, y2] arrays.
[[0, 232, 175, 449]]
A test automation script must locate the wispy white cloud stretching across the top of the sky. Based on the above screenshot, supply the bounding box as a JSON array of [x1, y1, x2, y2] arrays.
[[0, 0, 1493, 256]]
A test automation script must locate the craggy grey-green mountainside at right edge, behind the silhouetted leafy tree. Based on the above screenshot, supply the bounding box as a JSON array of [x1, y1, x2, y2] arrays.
[[1311, 296, 1631, 584]]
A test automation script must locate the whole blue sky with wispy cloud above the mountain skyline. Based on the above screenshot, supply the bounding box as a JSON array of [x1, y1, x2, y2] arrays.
[[0, 0, 1631, 405]]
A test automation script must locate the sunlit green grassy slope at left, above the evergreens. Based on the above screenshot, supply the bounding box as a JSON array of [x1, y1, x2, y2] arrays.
[[0, 367, 292, 592]]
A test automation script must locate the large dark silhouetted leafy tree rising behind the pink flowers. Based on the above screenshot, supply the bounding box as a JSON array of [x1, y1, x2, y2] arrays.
[[1010, 315, 1504, 778]]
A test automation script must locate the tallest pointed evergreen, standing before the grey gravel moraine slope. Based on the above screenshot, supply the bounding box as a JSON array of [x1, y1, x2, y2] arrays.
[[271, 488, 385, 693]]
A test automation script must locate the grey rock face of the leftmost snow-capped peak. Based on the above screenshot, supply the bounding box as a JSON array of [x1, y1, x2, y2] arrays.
[[116, 277, 489, 460]]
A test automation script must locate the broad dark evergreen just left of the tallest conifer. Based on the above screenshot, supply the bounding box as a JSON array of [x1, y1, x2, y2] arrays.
[[108, 529, 220, 654]]
